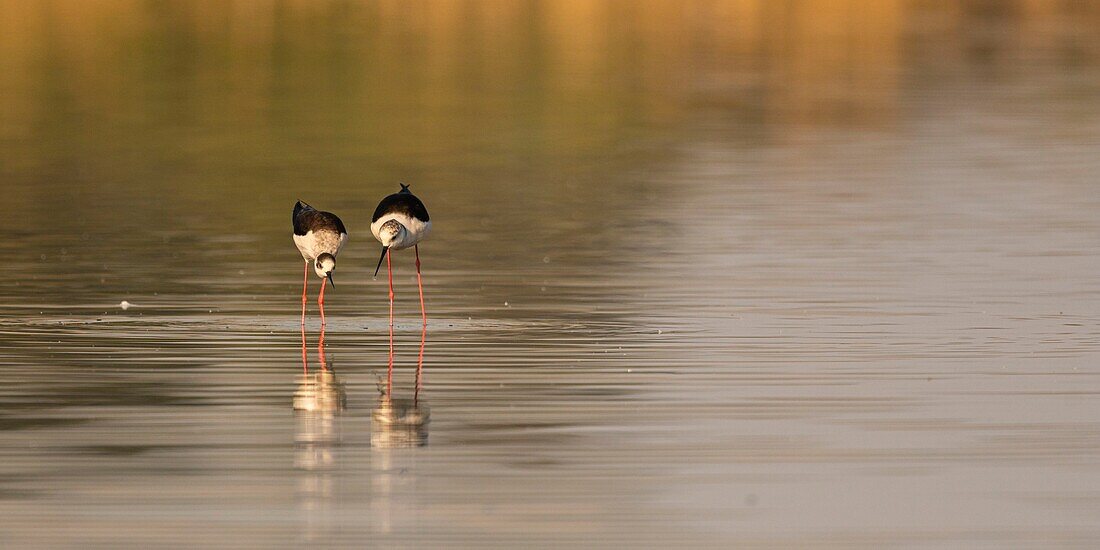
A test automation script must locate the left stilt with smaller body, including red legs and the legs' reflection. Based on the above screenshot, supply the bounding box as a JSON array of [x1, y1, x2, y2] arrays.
[[294, 200, 348, 373]]
